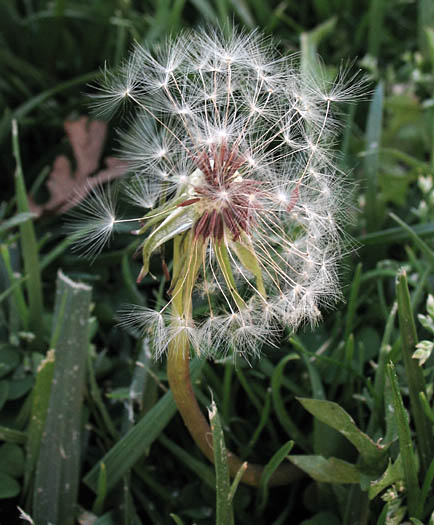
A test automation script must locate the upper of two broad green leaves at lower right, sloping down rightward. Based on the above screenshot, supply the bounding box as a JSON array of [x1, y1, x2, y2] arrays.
[[297, 398, 385, 470]]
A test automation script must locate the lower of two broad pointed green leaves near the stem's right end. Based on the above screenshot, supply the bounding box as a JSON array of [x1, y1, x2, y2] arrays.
[[289, 455, 360, 484]]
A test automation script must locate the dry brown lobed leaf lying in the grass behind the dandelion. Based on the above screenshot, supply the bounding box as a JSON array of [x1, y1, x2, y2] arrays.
[[29, 116, 127, 216]]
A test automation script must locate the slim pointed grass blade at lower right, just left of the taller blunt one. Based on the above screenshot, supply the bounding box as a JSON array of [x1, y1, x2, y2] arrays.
[[387, 363, 420, 518]]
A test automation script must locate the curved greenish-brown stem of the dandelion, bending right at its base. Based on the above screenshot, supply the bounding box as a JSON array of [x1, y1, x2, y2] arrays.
[[167, 235, 302, 487]]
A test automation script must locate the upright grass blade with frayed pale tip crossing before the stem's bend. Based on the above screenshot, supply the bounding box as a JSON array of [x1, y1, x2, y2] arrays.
[[208, 401, 234, 525]]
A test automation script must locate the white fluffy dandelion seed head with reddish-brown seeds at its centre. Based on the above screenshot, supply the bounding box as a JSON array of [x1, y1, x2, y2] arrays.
[[79, 29, 360, 357]]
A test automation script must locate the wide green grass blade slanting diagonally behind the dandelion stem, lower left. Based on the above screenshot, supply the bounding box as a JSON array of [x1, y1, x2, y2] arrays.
[[83, 359, 204, 493]]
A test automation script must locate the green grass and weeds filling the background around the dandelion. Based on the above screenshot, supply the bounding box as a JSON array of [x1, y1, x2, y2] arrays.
[[0, 0, 434, 525]]
